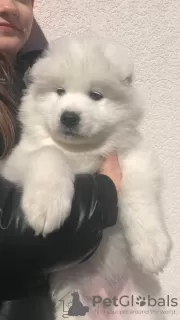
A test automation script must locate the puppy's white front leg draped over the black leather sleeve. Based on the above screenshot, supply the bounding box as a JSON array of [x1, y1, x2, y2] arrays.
[[22, 147, 74, 235]]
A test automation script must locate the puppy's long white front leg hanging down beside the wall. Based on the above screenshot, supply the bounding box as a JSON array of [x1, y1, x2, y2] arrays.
[[119, 141, 171, 273]]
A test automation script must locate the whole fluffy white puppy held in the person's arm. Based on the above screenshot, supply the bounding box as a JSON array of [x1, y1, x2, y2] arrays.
[[3, 37, 171, 319]]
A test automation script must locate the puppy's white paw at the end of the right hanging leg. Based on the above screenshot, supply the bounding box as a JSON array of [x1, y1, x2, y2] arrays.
[[131, 230, 172, 274]]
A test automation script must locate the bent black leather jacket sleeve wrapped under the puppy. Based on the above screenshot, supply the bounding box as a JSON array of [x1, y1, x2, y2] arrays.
[[0, 175, 117, 296]]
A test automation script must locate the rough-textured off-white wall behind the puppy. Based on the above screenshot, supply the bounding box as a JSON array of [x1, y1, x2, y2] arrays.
[[31, 0, 180, 320]]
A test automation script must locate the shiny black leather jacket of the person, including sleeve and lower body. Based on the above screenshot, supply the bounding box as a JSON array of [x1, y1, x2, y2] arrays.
[[0, 50, 117, 320]]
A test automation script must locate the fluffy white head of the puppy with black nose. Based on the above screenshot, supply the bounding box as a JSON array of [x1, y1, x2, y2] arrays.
[[24, 37, 140, 144]]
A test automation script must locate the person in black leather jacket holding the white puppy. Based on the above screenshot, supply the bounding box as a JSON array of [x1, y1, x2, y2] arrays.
[[0, 0, 121, 320]]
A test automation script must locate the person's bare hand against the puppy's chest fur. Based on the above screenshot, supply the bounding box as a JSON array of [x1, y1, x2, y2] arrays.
[[99, 153, 122, 192]]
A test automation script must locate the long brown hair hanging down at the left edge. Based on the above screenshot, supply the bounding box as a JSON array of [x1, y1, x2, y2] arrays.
[[0, 53, 16, 159]]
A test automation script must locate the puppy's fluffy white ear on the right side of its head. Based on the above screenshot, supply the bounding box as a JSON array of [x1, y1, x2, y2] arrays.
[[105, 42, 134, 85]]
